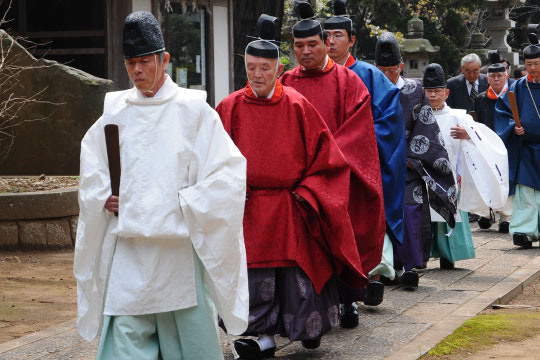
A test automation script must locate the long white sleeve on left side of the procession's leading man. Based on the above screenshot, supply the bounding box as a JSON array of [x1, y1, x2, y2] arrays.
[[73, 119, 116, 340]]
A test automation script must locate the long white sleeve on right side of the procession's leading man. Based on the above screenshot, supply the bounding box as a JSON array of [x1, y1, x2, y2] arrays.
[[179, 104, 249, 335]]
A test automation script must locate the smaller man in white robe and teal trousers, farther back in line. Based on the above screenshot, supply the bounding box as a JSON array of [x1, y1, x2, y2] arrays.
[[424, 64, 508, 269]]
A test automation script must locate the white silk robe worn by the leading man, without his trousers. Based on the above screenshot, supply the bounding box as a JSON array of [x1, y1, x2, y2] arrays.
[[74, 77, 249, 340]]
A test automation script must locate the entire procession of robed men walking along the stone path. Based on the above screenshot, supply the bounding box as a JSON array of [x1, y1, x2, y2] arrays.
[[74, 0, 540, 359]]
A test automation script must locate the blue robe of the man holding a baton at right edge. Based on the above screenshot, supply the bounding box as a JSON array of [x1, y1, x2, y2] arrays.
[[494, 77, 540, 195]]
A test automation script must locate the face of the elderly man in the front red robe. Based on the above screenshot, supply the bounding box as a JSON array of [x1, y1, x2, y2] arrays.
[[246, 54, 283, 97]]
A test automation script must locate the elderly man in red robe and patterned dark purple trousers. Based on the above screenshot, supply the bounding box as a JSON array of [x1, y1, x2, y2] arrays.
[[217, 14, 367, 359]]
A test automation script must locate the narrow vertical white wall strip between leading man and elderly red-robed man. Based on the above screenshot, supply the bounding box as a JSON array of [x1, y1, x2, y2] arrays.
[[210, 6, 230, 106]]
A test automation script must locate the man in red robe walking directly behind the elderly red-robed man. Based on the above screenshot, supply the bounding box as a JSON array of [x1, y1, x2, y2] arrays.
[[281, 1, 386, 327]]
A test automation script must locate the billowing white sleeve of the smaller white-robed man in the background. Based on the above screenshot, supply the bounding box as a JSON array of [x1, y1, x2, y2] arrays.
[[459, 116, 508, 213]]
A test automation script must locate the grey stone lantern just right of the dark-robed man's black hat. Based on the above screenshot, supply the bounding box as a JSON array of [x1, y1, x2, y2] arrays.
[[401, 14, 440, 78]]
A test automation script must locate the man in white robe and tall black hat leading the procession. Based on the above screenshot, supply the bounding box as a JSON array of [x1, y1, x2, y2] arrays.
[[74, 12, 249, 360]]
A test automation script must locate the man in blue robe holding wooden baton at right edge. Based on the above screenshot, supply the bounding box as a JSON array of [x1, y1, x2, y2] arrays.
[[494, 33, 540, 248]]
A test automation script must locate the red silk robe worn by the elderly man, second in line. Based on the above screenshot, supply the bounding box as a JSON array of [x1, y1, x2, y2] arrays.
[[216, 81, 367, 293]]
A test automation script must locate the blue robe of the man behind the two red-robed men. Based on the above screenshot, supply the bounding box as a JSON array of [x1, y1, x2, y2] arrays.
[[349, 60, 407, 244]]
